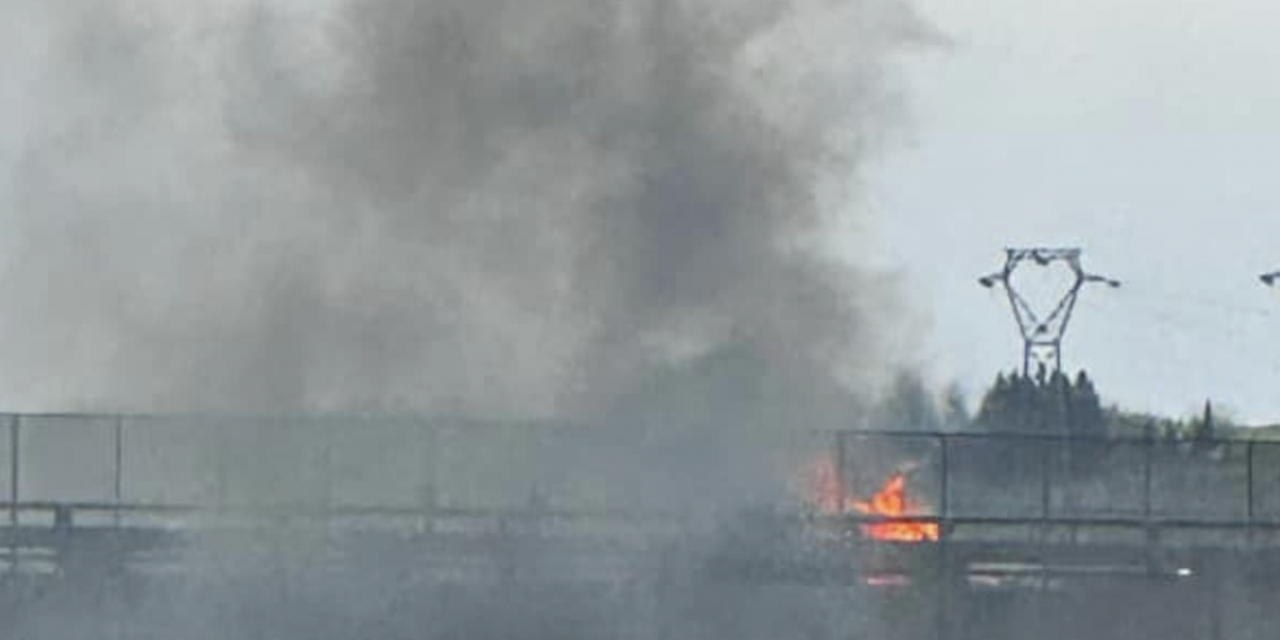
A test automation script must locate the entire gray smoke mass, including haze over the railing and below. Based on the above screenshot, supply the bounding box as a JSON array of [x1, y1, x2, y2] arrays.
[[0, 6, 923, 640]]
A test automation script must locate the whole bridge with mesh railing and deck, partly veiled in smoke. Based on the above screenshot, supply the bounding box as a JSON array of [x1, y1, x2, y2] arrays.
[[0, 415, 1280, 640]]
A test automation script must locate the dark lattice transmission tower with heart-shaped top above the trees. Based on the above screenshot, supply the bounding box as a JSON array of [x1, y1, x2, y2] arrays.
[[978, 247, 1120, 375]]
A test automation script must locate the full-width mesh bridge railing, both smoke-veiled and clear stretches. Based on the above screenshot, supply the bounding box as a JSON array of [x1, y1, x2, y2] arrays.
[[0, 415, 1280, 527]]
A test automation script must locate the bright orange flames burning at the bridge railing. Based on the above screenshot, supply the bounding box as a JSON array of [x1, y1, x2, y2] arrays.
[[809, 457, 940, 543]]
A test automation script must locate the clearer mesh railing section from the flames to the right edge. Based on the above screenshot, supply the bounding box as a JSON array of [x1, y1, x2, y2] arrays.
[[840, 431, 1280, 527]]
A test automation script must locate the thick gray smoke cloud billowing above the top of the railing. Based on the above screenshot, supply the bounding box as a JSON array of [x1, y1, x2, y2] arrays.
[[0, 0, 922, 416]]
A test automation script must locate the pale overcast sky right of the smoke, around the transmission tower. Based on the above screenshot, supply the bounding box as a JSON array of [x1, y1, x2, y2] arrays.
[[872, 0, 1280, 421]]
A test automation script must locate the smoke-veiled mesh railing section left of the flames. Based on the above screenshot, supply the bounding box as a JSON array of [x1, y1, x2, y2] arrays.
[[0, 415, 832, 524]]
